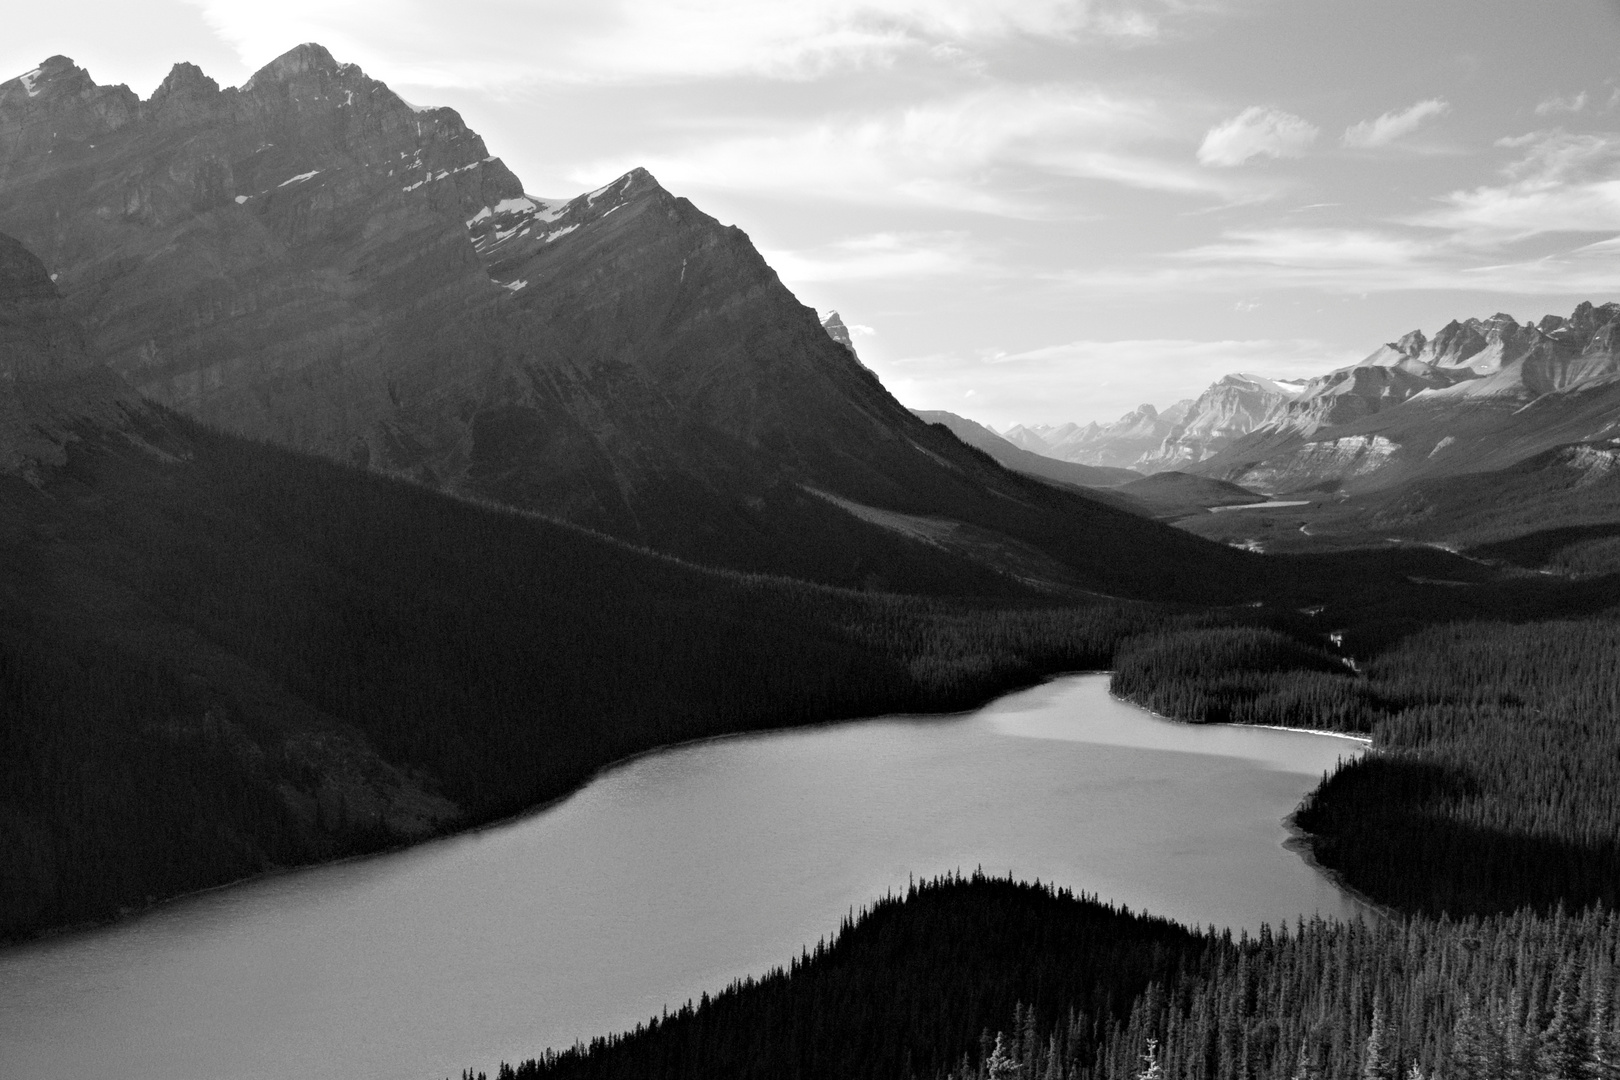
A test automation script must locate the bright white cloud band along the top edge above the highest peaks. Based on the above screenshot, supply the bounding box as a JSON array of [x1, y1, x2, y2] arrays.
[[190, 0, 1196, 87]]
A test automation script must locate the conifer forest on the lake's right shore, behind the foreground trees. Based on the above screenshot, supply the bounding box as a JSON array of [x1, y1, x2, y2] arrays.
[[1113, 615, 1620, 915]]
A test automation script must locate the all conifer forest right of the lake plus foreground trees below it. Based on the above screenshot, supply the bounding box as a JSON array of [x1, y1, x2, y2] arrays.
[[450, 550, 1620, 1080]]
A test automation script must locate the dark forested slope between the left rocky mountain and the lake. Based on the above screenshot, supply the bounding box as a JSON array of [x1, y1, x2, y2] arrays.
[[0, 228, 1218, 939]]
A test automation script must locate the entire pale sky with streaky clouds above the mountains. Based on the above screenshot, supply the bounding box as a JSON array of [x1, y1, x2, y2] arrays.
[[0, 0, 1620, 429]]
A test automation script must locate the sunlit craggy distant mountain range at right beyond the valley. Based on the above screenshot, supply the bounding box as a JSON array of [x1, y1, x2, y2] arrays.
[[1004, 303, 1620, 492]]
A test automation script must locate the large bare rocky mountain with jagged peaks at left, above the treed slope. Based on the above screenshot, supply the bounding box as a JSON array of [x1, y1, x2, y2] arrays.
[[0, 45, 1252, 605]]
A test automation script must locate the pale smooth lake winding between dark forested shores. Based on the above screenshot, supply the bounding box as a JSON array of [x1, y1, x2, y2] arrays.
[[0, 675, 1361, 1080]]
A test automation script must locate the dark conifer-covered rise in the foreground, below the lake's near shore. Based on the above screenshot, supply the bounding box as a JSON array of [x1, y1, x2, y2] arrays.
[[450, 874, 1620, 1080]]
